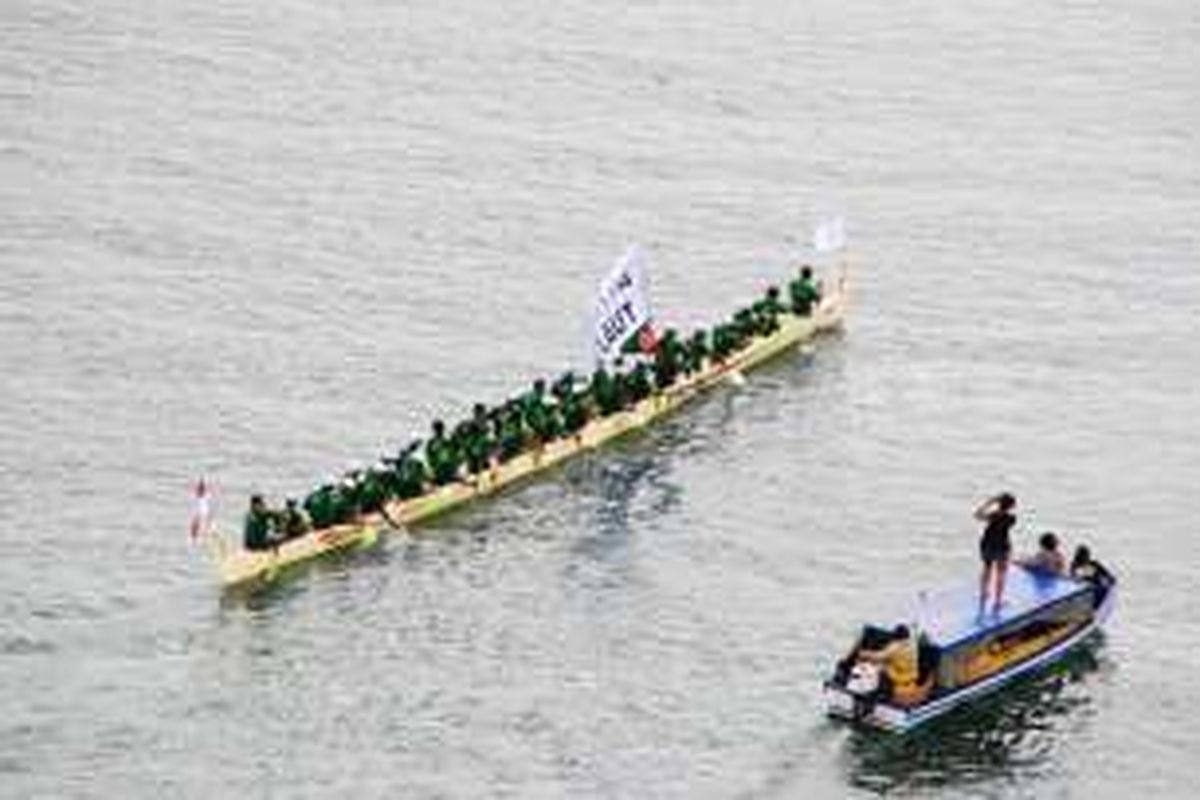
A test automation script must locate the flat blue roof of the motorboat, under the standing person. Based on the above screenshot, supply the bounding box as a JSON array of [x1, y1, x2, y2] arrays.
[[911, 565, 1090, 649]]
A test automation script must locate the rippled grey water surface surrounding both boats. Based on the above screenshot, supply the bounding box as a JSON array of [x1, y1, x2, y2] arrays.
[[0, 0, 1200, 798]]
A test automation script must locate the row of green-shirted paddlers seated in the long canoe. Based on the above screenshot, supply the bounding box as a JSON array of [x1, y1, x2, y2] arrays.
[[245, 266, 821, 549]]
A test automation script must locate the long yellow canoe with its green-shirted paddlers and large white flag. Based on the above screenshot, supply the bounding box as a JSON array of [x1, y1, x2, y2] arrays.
[[201, 237, 848, 588]]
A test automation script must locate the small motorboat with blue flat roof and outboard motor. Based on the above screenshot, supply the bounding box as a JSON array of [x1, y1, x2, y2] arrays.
[[824, 566, 1117, 732]]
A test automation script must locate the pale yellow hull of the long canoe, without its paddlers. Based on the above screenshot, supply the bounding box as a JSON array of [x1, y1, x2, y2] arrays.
[[214, 268, 848, 588]]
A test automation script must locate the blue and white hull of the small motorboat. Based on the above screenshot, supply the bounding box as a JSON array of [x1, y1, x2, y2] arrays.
[[824, 585, 1117, 733]]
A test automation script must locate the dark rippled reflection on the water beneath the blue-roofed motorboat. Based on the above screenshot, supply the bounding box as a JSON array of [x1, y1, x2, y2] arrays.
[[842, 636, 1105, 794]]
